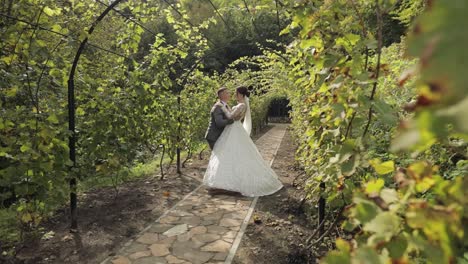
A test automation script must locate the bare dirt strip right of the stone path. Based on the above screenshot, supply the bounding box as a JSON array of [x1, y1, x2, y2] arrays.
[[233, 128, 332, 264]]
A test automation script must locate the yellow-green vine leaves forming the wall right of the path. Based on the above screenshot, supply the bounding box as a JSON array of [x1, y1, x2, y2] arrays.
[[272, 1, 468, 263]]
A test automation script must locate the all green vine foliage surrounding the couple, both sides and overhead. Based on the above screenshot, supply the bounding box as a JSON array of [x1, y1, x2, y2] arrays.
[[0, 0, 468, 263]]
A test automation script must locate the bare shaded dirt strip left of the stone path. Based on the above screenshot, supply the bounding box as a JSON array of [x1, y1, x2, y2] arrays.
[[0, 126, 271, 264]]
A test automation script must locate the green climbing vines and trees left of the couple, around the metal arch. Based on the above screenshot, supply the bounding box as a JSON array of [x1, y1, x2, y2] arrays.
[[0, 0, 286, 250]]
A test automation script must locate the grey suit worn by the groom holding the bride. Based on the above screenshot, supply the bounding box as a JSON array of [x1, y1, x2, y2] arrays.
[[205, 102, 234, 149]]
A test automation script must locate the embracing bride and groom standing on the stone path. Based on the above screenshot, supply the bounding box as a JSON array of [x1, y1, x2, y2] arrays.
[[203, 86, 283, 197]]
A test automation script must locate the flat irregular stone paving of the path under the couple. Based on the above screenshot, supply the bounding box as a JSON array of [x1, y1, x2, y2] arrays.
[[102, 124, 287, 264]]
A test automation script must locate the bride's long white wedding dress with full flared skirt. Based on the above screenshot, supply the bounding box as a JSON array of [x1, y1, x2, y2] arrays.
[[203, 97, 283, 197]]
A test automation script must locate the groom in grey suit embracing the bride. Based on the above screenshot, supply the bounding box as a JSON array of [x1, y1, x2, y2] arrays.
[[205, 87, 234, 149]]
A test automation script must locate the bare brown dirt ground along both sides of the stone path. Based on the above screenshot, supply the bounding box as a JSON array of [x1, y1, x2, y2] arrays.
[[0, 126, 333, 264]]
